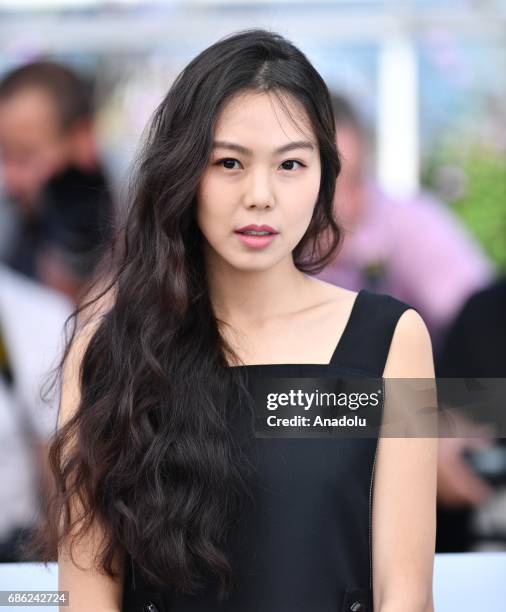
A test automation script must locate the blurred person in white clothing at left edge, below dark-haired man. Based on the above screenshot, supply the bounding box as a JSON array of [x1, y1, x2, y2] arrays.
[[0, 264, 71, 562]]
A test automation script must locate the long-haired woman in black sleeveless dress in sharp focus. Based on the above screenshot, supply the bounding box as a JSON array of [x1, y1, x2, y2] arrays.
[[29, 29, 436, 612]]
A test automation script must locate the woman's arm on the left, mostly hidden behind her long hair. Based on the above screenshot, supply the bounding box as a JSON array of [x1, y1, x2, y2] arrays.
[[58, 314, 122, 612]]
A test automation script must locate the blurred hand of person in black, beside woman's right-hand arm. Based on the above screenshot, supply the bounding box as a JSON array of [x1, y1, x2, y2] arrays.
[[437, 415, 494, 508]]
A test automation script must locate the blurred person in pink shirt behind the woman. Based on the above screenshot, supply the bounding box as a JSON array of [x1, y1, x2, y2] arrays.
[[319, 94, 494, 354]]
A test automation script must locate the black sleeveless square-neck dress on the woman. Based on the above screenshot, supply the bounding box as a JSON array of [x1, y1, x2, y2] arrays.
[[122, 290, 412, 612]]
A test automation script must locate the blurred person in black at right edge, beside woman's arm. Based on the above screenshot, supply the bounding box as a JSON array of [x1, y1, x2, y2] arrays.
[[436, 277, 506, 552]]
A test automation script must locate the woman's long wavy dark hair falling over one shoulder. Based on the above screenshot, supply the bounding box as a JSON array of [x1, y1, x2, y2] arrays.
[[24, 29, 340, 597]]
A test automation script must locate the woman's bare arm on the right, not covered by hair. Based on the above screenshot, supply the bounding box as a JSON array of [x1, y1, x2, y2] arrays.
[[372, 309, 438, 612]]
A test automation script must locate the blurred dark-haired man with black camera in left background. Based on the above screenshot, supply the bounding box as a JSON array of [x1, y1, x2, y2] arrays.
[[0, 61, 114, 300]]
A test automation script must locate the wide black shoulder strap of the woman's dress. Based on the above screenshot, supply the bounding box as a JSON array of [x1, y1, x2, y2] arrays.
[[330, 289, 417, 378]]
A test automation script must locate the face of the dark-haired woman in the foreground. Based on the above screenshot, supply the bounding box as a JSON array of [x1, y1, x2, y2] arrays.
[[197, 92, 321, 270]]
